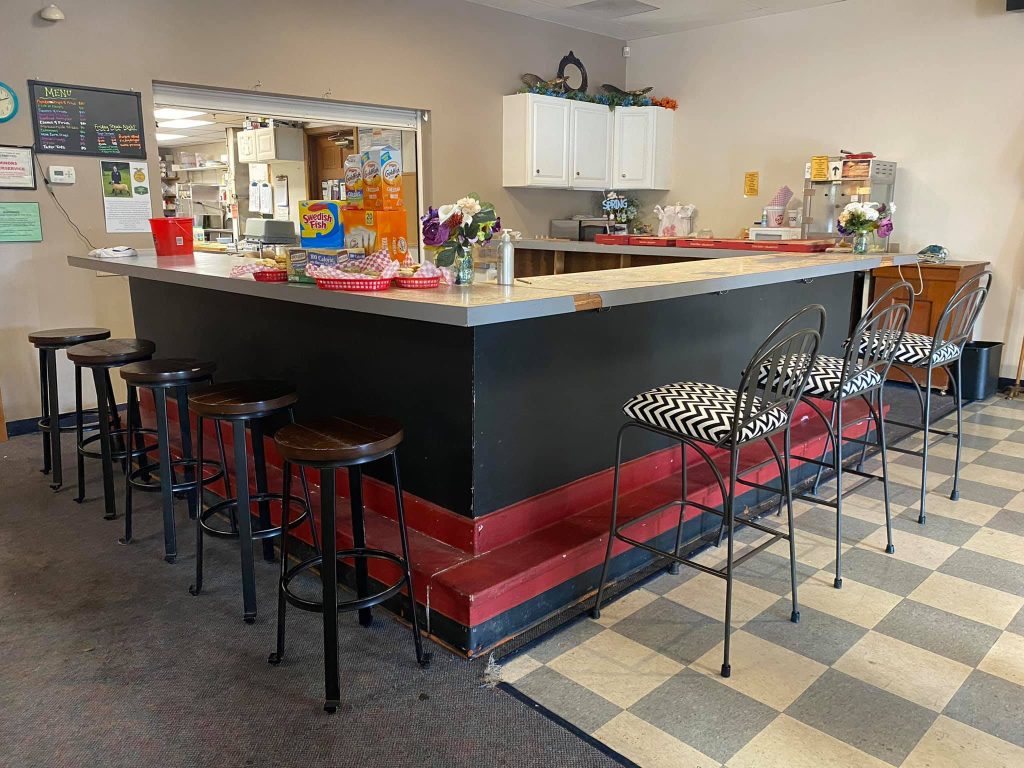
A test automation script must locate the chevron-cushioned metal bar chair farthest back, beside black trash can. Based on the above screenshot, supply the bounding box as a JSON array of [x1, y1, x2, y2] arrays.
[[872, 270, 992, 524]]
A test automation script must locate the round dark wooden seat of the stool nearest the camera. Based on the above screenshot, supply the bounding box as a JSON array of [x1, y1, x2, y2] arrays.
[[273, 416, 402, 466]]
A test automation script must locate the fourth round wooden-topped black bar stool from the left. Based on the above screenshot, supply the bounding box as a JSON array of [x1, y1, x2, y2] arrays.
[[188, 380, 319, 624]]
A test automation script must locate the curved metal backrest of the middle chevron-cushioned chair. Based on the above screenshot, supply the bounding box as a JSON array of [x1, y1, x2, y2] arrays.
[[839, 281, 913, 392]]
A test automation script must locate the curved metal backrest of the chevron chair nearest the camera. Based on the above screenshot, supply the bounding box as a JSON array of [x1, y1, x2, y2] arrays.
[[731, 304, 825, 444]]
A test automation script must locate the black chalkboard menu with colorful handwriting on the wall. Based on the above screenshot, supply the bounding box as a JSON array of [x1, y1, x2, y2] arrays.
[[29, 80, 145, 160]]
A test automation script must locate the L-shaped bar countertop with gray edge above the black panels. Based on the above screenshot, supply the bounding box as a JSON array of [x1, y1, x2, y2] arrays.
[[68, 250, 915, 327]]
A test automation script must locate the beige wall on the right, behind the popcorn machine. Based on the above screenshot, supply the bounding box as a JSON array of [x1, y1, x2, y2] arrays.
[[629, 0, 1024, 377]]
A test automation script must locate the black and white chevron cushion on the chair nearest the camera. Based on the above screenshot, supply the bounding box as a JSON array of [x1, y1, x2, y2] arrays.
[[623, 381, 787, 443]]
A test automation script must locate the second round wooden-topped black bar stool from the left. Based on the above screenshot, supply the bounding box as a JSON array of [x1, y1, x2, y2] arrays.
[[68, 339, 157, 520]]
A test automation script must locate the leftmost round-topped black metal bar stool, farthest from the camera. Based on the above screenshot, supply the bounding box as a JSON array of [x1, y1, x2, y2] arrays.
[[29, 328, 111, 490]]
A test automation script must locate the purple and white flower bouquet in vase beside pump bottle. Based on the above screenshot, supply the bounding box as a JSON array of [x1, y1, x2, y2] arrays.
[[420, 195, 502, 285]]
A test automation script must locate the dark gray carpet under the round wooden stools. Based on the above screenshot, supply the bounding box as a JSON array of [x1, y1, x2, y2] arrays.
[[0, 435, 615, 768]]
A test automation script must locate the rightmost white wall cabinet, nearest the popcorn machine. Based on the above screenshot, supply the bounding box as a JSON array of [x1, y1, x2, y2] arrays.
[[611, 106, 673, 189]]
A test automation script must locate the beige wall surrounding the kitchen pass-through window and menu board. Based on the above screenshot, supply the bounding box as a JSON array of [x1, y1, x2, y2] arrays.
[[0, 0, 626, 420]]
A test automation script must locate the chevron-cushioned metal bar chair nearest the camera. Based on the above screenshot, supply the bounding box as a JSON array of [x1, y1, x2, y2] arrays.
[[591, 304, 825, 677]]
